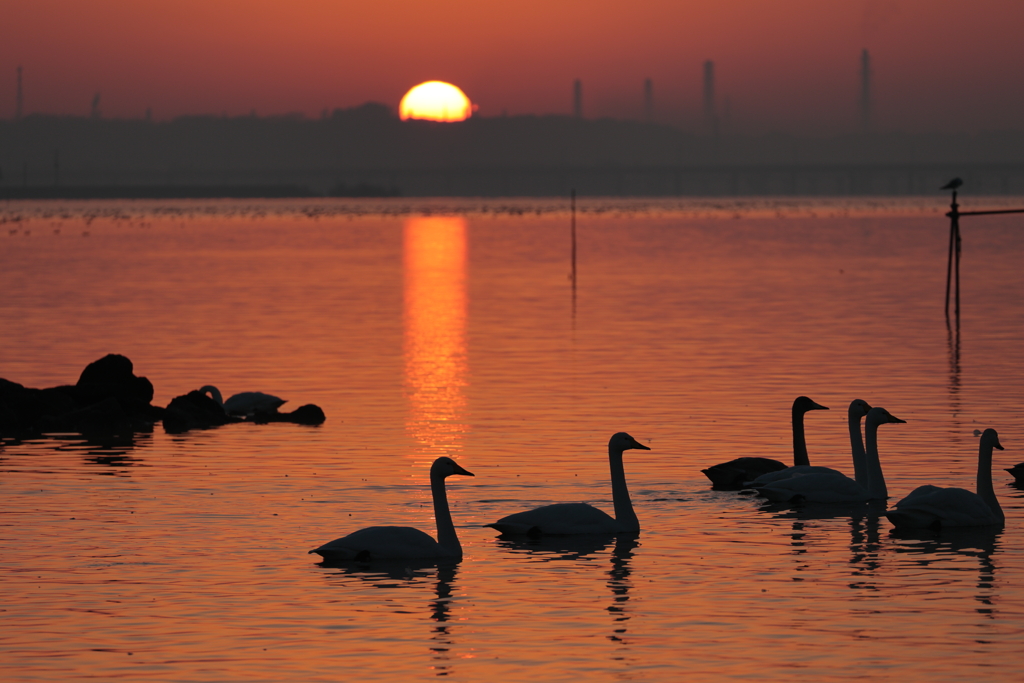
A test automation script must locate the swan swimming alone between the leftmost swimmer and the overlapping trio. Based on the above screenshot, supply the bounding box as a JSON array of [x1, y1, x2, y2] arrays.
[[486, 432, 650, 537]]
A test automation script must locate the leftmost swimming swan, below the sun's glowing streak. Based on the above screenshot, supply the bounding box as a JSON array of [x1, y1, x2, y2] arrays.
[[309, 457, 475, 562]]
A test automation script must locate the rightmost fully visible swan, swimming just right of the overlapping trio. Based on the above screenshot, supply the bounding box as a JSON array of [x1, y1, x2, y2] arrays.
[[885, 429, 1006, 529]]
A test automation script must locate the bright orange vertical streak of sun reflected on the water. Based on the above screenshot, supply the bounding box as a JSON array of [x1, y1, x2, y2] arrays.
[[403, 216, 468, 455]]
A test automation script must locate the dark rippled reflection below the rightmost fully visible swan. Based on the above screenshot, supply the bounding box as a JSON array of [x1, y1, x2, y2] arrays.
[[890, 526, 1002, 618]]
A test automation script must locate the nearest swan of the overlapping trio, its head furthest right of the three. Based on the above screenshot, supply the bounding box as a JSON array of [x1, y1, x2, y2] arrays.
[[755, 408, 906, 503]]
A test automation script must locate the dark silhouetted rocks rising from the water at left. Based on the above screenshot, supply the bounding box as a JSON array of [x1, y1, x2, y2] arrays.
[[0, 353, 326, 436]]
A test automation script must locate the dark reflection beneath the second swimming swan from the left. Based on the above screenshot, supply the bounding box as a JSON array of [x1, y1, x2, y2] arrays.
[[497, 533, 640, 643]]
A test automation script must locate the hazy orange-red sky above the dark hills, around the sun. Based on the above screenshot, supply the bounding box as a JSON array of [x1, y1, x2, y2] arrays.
[[0, 0, 1024, 132]]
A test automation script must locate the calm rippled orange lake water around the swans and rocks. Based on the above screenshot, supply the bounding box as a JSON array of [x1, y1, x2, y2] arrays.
[[0, 198, 1024, 681]]
